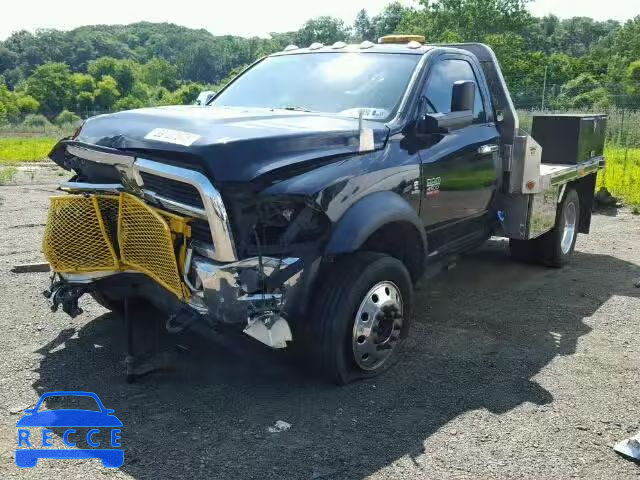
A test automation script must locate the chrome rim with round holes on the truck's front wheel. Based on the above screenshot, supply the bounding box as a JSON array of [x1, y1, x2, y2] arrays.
[[352, 281, 403, 370]]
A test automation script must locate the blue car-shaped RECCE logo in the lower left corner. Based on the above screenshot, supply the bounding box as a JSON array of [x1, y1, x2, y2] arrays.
[[15, 392, 124, 468]]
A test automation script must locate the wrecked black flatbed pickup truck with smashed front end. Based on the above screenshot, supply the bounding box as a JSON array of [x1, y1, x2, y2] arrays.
[[43, 36, 606, 383]]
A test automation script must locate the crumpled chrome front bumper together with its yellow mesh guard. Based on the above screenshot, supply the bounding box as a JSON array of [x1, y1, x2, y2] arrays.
[[43, 193, 304, 348]]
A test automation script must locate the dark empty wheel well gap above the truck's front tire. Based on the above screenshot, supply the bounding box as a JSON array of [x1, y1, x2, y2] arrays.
[[360, 222, 426, 283]]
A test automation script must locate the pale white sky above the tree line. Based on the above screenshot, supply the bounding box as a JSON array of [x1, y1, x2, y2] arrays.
[[0, 0, 640, 40]]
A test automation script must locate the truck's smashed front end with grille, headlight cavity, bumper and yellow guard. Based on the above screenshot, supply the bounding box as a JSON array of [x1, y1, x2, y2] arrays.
[[43, 141, 329, 348]]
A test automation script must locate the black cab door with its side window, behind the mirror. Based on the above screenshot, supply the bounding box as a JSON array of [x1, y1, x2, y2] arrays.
[[419, 54, 500, 248]]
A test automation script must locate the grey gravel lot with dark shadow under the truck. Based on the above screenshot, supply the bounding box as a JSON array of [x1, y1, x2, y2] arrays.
[[0, 171, 640, 479]]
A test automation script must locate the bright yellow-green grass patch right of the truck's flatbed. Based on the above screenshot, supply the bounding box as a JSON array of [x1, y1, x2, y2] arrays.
[[596, 145, 640, 207]]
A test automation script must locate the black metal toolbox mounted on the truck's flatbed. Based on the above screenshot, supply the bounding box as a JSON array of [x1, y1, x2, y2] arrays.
[[531, 114, 607, 165]]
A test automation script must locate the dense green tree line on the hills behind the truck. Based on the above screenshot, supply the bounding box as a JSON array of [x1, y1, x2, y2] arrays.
[[0, 0, 640, 124]]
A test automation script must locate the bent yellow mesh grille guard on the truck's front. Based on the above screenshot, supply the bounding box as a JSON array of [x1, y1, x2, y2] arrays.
[[42, 193, 191, 301]]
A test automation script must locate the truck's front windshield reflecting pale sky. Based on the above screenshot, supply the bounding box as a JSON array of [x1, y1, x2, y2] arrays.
[[211, 52, 420, 121]]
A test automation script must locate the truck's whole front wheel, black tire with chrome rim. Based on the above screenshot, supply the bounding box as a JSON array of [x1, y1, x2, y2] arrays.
[[302, 252, 413, 385]]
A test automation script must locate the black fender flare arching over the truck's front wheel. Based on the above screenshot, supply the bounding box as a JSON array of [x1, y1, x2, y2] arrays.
[[324, 191, 428, 257]]
